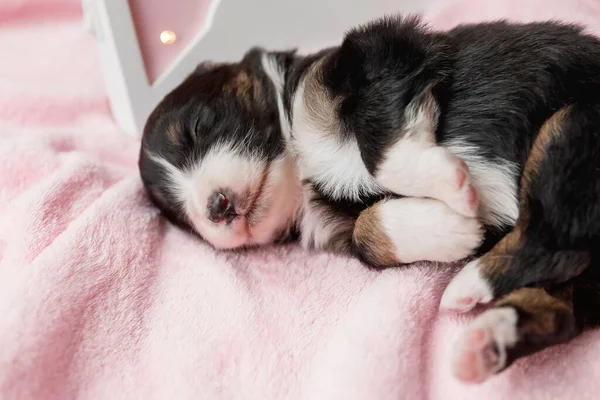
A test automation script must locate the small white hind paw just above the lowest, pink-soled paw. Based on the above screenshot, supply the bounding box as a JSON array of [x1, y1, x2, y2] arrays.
[[440, 260, 494, 312]]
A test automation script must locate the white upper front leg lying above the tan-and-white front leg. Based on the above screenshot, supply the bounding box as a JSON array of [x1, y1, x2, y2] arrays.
[[374, 90, 477, 217]]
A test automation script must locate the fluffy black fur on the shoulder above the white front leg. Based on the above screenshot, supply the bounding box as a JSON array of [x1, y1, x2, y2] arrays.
[[323, 18, 453, 173]]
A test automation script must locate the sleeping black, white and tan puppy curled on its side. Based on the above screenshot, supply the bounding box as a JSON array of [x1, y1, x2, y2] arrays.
[[140, 18, 600, 382]]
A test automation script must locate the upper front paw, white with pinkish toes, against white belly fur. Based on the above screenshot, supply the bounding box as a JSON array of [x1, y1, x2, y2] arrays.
[[434, 147, 479, 218]]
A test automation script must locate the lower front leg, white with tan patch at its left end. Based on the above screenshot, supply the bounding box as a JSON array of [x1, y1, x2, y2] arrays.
[[353, 198, 483, 267]]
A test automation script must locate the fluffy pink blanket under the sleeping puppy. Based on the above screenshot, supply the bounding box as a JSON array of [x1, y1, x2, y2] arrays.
[[0, 0, 600, 400]]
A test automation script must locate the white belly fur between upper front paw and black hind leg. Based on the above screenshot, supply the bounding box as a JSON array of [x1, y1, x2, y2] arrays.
[[444, 140, 519, 226]]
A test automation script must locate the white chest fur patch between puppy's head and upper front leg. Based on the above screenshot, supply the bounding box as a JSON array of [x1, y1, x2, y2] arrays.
[[292, 82, 383, 200]]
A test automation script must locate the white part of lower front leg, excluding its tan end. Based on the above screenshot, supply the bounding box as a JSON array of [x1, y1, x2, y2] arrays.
[[377, 198, 483, 263]]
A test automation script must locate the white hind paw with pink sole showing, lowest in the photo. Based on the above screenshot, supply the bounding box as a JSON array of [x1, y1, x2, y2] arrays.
[[452, 307, 518, 383]]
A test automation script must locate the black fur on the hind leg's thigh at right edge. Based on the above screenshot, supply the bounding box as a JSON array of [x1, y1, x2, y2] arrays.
[[491, 103, 600, 295]]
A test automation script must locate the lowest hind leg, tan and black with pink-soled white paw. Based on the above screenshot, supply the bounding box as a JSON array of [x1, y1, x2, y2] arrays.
[[452, 284, 580, 383]]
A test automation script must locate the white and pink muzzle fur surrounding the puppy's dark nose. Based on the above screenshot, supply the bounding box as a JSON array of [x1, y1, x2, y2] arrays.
[[152, 145, 299, 248]]
